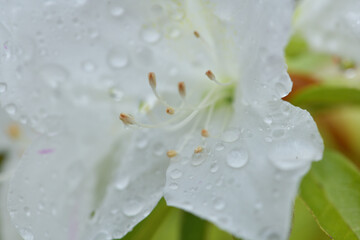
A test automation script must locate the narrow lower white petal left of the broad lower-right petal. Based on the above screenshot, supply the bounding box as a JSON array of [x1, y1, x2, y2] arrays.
[[84, 128, 169, 239]]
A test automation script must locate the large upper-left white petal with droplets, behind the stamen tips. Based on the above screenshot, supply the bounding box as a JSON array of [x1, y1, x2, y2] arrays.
[[0, 0, 217, 134]]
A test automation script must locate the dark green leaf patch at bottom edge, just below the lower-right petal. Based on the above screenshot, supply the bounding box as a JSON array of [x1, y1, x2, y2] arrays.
[[181, 212, 206, 240]]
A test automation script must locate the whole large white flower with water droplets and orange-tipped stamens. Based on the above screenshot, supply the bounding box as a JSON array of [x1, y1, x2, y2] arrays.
[[0, 0, 323, 240]]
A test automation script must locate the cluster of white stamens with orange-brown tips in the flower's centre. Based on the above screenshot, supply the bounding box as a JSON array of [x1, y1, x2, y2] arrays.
[[119, 70, 235, 158]]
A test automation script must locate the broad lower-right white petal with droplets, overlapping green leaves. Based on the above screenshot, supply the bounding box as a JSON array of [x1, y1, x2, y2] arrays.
[[165, 101, 323, 240]]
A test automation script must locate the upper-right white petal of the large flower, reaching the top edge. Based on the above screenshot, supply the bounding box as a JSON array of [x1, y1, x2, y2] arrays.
[[200, 0, 294, 103]]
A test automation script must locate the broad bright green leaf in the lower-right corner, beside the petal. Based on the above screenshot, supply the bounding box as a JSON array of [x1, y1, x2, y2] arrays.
[[300, 150, 360, 240]]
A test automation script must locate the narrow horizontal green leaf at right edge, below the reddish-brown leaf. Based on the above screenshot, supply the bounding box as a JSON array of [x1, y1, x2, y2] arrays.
[[290, 85, 360, 111]]
